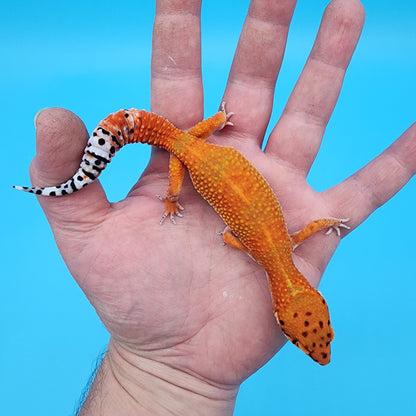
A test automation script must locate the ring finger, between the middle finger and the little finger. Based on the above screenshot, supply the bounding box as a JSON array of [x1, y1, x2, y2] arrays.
[[266, 0, 365, 176]]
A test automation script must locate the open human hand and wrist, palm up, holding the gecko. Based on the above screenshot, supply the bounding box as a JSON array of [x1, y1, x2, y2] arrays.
[[26, 0, 416, 416]]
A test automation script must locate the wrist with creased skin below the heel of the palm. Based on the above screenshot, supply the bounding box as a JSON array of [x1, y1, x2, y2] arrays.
[[79, 341, 238, 416]]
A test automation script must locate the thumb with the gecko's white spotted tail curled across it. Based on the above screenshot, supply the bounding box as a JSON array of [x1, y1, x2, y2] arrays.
[[30, 108, 109, 231]]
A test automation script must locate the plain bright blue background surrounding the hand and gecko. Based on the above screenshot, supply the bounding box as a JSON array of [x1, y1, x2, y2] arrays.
[[0, 0, 416, 416]]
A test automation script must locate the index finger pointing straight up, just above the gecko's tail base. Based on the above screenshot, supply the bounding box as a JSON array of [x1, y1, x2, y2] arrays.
[[151, 0, 203, 129]]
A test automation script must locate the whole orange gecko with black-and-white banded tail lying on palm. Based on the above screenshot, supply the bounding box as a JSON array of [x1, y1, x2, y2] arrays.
[[15, 104, 349, 365]]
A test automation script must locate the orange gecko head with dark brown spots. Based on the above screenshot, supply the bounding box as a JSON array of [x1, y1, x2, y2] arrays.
[[275, 288, 334, 365]]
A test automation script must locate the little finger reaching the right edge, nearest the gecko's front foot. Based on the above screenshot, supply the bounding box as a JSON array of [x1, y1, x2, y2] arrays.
[[323, 123, 416, 227]]
